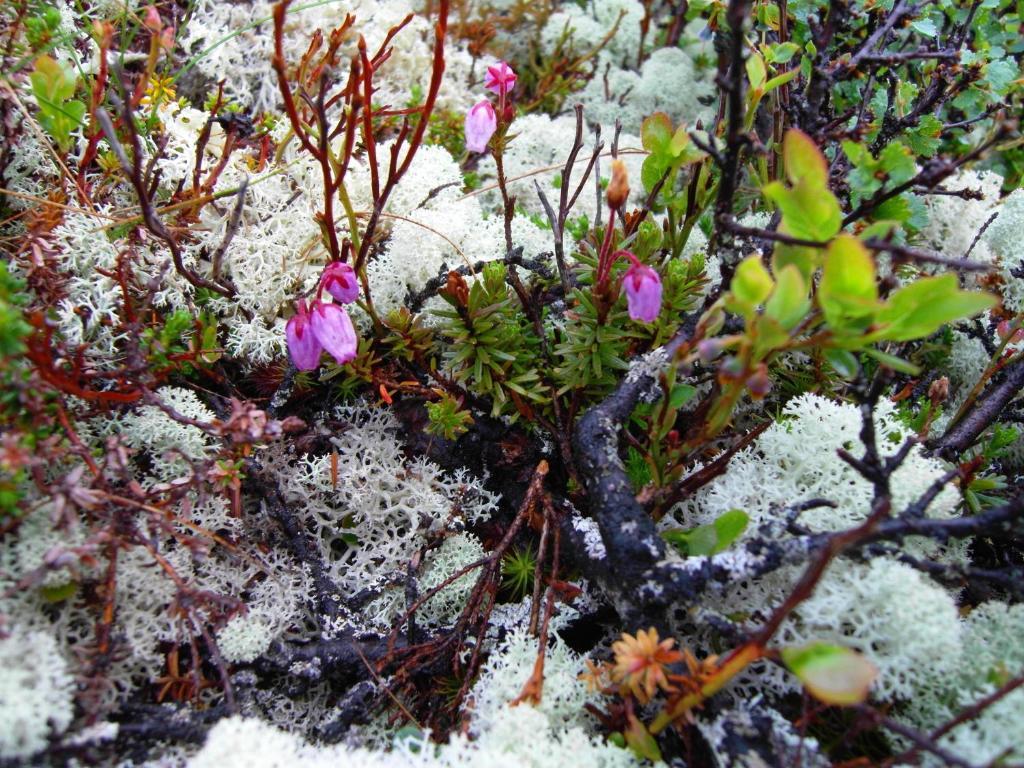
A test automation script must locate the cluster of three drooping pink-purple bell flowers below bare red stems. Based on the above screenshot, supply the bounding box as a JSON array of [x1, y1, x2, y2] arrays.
[[285, 261, 359, 371]]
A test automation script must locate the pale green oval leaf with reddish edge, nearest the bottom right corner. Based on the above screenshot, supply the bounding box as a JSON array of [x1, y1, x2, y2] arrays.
[[781, 643, 879, 707]]
